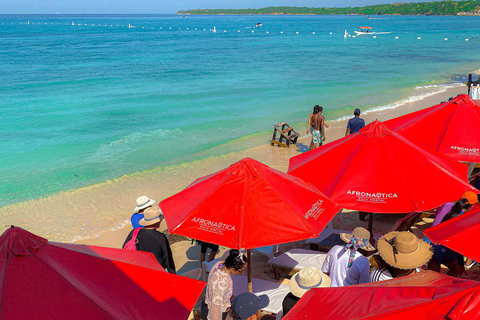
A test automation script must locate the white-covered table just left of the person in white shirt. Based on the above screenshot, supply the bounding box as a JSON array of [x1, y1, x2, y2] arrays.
[[268, 249, 327, 270]]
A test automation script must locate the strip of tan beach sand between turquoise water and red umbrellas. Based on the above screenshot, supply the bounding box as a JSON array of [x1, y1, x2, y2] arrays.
[[0, 87, 478, 278]]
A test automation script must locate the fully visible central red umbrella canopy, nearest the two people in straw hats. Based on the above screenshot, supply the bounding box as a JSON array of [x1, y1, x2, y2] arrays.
[[159, 158, 341, 249]]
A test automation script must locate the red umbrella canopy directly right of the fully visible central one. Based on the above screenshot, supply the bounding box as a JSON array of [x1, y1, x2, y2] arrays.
[[288, 121, 476, 213]]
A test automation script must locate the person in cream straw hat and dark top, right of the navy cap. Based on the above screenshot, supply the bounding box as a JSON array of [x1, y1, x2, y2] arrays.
[[282, 267, 332, 318]]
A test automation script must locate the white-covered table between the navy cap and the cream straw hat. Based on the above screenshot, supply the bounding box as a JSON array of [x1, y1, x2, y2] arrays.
[[232, 275, 290, 314]]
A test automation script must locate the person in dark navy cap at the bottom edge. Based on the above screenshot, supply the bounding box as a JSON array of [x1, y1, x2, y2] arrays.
[[227, 292, 270, 320]]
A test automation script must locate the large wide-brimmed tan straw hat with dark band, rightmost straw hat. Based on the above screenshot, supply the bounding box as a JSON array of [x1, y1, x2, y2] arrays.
[[377, 231, 433, 270]]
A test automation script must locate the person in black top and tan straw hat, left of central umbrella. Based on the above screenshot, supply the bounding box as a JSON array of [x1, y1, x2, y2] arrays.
[[122, 206, 176, 273]]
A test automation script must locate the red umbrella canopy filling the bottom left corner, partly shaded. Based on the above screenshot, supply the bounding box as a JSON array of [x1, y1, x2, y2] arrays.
[[0, 227, 205, 319]]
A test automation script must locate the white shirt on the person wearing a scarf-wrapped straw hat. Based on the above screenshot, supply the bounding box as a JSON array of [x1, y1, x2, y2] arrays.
[[322, 246, 370, 287]]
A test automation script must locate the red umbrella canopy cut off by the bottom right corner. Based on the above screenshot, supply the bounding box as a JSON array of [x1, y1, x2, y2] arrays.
[[283, 271, 480, 320]]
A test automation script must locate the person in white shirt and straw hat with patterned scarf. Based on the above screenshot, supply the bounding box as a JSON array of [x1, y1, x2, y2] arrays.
[[322, 227, 375, 287]]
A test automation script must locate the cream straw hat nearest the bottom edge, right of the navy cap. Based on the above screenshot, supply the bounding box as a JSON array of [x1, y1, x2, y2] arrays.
[[289, 267, 332, 298]]
